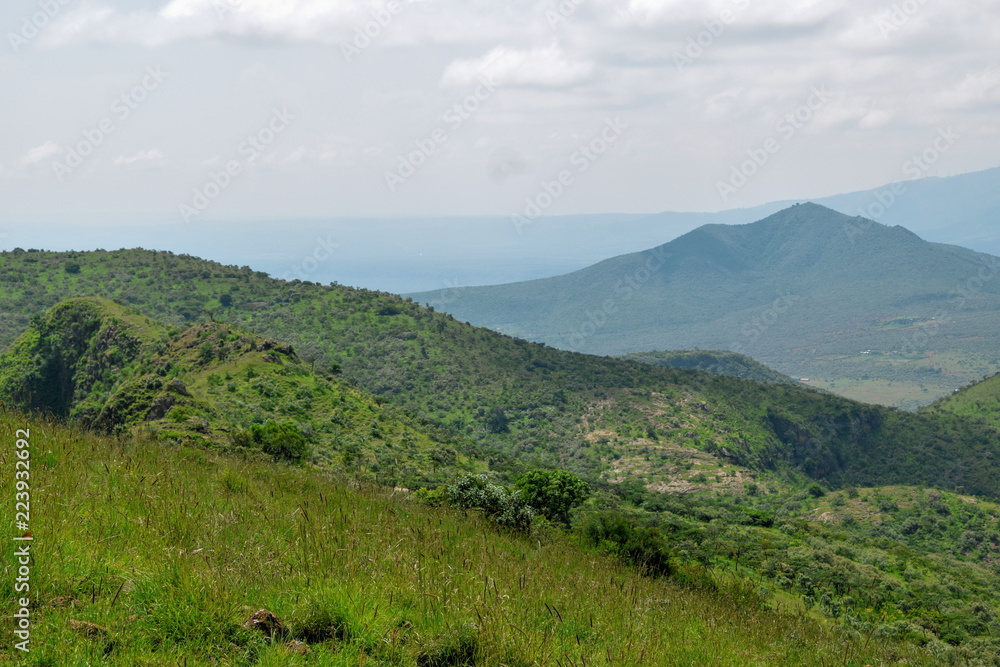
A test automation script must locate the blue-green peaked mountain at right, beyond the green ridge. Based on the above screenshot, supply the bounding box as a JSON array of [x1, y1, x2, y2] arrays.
[[411, 204, 1000, 410]]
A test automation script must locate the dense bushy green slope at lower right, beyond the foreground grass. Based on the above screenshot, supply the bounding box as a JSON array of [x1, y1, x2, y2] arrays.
[[581, 486, 1000, 665]]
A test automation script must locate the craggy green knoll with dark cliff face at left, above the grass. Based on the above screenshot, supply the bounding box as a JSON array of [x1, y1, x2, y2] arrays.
[[0, 297, 475, 485]]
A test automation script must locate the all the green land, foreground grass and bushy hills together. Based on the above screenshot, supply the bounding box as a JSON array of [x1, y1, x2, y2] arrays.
[[0, 251, 1000, 666]]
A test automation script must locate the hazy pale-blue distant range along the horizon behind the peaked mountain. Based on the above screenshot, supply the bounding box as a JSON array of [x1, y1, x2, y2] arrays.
[[11, 168, 1000, 294]]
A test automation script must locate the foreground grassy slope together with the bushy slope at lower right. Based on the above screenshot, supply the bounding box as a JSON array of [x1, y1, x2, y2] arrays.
[[9, 410, 1000, 667]]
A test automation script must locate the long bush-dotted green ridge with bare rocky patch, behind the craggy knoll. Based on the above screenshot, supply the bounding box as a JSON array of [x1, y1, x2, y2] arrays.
[[0, 250, 1000, 496]]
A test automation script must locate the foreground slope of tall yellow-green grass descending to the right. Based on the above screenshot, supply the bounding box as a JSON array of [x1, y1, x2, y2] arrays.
[[0, 411, 928, 667]]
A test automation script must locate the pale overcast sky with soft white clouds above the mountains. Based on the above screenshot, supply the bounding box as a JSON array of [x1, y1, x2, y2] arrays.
[[0, 0, 1000, 226]]
